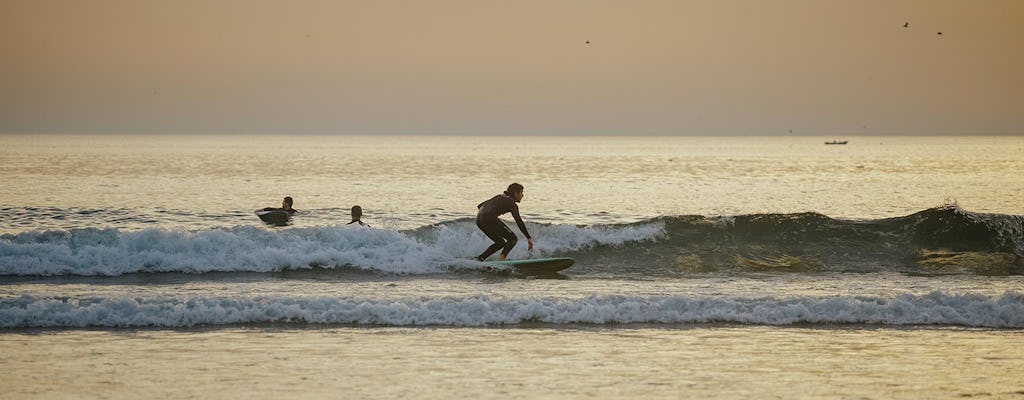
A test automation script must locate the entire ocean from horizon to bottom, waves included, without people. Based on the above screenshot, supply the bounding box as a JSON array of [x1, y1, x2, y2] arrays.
[[0, 135, 1024, 399]]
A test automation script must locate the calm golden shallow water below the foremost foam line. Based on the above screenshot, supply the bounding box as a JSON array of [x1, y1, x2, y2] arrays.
[[0, 324, 1024, 399]]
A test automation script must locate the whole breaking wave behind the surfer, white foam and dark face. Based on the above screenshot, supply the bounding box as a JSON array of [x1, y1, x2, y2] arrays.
[[0, 206, 1024, 276]]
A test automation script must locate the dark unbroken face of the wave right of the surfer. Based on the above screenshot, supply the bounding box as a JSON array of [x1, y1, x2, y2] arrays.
[[574, 206, 1024, 275]]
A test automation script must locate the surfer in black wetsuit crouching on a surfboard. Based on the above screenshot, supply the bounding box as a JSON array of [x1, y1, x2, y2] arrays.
[[476, 183, 534, 261]]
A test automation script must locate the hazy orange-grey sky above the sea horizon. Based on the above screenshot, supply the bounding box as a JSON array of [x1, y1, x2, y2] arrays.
[[0, 0, 1024, 135]]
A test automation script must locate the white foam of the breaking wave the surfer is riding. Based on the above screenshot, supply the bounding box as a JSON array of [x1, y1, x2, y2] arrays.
[[0, 222, 664, 276]]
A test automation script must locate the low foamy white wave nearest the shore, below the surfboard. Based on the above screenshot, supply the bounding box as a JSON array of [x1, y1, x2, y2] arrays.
[[0, 291, 1024, 328]]
